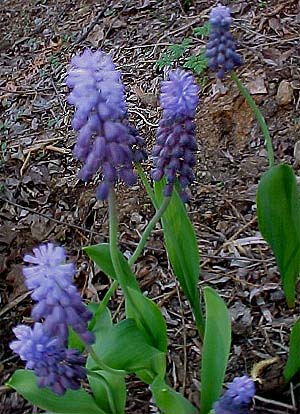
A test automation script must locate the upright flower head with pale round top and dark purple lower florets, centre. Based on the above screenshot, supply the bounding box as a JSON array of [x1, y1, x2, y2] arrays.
[[152, 69, 199, 202]]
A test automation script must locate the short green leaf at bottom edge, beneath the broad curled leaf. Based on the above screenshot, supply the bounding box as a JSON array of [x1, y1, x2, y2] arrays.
[[88, 371, 126, 414]]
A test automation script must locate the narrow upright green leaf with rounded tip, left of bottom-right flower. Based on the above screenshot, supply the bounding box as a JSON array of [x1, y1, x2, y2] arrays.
[[200, 287, 231, 414]]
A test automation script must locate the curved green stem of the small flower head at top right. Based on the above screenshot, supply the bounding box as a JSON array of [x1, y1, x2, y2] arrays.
[[230, 72, 274, 168]]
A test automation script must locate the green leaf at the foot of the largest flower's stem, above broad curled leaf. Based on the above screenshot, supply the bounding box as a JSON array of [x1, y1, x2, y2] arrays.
[[126, 288, 168, 353]]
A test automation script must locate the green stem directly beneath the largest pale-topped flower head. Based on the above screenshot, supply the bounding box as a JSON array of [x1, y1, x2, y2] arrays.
[[108, 187, 127, 296]]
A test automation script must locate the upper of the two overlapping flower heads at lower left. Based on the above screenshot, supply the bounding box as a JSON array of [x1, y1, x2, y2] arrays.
[[23, 243, 94, 344]]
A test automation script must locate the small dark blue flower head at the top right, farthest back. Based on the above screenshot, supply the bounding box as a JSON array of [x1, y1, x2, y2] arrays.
[[206, 4, 242, 79]]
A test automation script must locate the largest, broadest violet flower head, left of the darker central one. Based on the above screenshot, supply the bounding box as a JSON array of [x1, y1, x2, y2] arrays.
[[66, 49, 145, 200]]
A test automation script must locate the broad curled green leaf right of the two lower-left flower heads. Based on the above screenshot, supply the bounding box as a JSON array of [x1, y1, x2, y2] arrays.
[[88, 319, 166, 383]]
